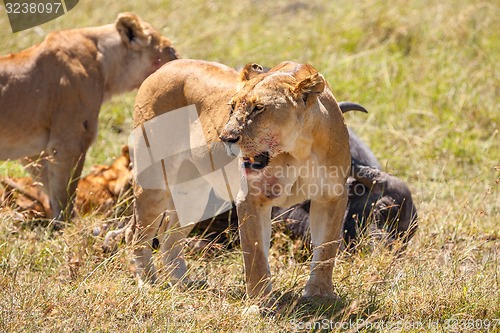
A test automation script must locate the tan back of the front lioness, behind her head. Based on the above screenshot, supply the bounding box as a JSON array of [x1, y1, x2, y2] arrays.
[[134, 59, 239, 141]]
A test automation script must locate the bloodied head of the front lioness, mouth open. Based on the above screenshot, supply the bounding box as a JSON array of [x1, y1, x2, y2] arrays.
[[220, 62, 325, 169]]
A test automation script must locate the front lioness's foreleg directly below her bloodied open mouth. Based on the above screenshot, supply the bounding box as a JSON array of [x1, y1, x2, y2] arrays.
[[236, 198, 272, 298]]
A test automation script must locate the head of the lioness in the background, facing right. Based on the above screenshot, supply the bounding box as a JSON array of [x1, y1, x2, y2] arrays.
[[104, 13, 178, 93]]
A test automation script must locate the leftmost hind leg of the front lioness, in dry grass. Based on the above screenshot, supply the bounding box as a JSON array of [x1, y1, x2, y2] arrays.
[[133, 189, 169, 287]]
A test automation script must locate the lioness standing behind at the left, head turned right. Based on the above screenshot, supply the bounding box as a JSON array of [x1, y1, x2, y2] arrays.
[[0, 13, 177, 220]]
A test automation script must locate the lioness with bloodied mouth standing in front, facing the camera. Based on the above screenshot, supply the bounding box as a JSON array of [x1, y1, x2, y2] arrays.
[[134, 60, 351, 304]]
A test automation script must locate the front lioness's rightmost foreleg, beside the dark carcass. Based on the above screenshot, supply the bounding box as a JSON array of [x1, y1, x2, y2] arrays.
[[304, 195, 347, 297]]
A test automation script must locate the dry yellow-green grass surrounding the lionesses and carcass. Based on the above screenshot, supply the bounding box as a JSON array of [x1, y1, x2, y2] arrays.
[[0, 0, 500, 332]]
